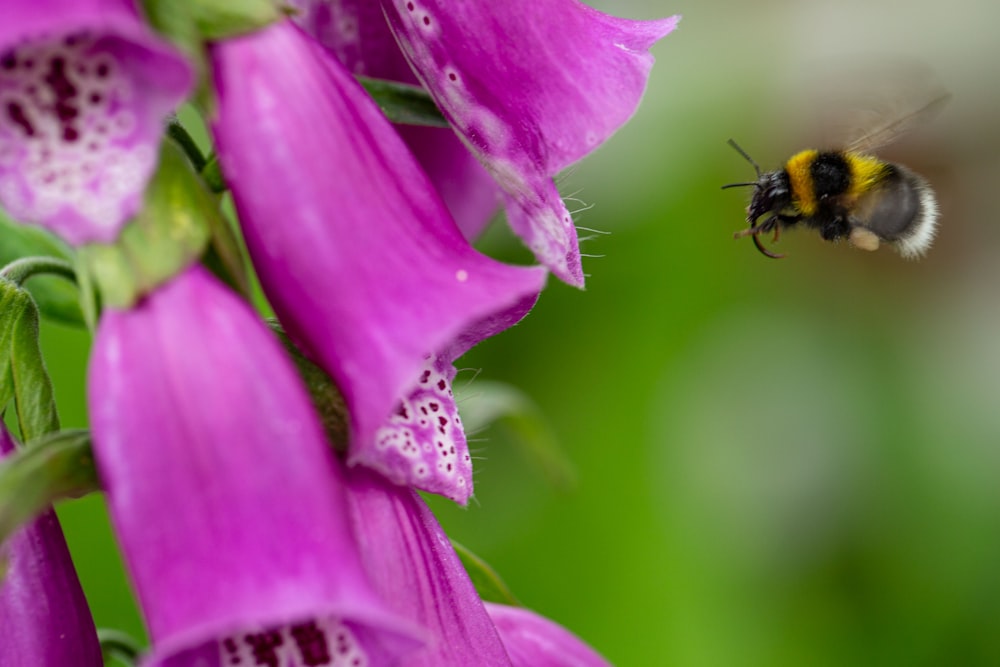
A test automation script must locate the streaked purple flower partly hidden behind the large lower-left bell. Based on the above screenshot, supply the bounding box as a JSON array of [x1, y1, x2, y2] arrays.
[[347, 468, 510, 667]]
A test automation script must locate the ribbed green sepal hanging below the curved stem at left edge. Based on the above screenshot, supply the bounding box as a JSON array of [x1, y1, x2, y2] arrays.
[[0, 278, 59, 442]]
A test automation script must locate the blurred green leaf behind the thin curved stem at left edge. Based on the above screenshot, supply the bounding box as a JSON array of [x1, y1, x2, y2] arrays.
[[0, 214, 84, 326]]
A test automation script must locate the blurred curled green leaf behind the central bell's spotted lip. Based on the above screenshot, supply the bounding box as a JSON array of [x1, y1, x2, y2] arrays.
[[456, 381, 576, 490]]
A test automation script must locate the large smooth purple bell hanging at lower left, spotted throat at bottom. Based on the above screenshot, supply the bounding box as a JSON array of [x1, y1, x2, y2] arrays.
[[88, 267, 413, 665]]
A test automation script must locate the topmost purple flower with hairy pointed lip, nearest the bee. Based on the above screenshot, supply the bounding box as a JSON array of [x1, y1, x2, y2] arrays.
[[381, 0, 678, 285]]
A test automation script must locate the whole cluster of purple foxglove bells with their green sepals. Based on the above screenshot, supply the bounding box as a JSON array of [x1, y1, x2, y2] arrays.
[[0, 0, 677, 667]]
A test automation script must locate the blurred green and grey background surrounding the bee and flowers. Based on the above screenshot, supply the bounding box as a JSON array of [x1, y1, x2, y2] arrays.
[[29, 0, 1000, 666]]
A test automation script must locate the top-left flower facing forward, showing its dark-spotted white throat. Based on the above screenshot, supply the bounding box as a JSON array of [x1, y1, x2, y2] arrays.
[[0, 0, 193, 244]]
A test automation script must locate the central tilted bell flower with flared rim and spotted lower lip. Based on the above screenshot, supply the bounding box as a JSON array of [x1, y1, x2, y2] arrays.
[[211, 22, 545, 502]]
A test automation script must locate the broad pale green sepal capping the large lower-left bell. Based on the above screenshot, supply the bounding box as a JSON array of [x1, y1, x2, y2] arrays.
[[78, 139, 226, 309]]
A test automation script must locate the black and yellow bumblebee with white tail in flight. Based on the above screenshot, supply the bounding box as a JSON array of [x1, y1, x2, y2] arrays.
[[723, 96, 947, 259]]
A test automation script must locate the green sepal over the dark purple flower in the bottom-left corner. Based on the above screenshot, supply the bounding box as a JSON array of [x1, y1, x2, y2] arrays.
[[0, 430, 100, 543]]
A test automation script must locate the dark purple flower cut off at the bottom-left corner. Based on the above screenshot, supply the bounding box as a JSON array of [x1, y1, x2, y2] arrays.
[[0, 424, 104, 667]]
